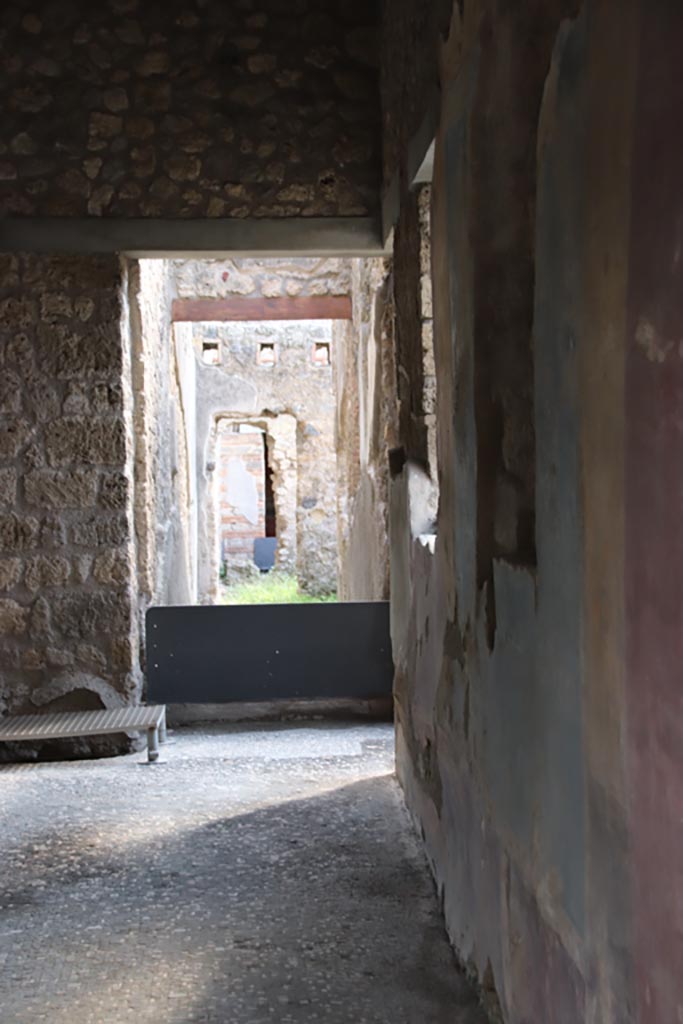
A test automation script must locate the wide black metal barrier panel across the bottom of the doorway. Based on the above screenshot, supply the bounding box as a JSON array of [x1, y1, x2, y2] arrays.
[[146, 601, 393, 703]]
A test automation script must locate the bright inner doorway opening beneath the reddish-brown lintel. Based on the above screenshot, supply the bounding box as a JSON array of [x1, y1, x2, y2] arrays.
[[188, 319, 340, 604]]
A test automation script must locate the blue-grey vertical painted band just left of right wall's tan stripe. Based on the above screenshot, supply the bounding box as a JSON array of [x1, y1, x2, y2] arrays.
[[535, 12, 587, 934]]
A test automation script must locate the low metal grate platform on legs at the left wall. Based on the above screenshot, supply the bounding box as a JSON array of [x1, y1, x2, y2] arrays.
[[0, 705, 166, 761]]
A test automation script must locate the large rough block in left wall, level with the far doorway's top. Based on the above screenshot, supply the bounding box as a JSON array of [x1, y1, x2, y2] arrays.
[[45, 416, 126, 466]]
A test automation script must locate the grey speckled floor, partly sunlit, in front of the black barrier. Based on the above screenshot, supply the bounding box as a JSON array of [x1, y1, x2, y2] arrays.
[[0, 725, 491, 1024]]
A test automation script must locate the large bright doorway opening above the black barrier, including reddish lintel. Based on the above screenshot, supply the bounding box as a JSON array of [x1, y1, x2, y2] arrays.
[[125, 258, 397, 604]]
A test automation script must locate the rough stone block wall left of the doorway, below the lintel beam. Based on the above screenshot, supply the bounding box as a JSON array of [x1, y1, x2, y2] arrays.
[[0, 255, 140, 737]]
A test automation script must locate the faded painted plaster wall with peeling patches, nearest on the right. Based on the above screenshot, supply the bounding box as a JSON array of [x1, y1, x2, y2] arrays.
[[383, 0, 683, 1024]]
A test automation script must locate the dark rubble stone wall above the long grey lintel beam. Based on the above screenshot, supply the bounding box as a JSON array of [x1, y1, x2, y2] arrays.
[[0, 0, 380, 218]]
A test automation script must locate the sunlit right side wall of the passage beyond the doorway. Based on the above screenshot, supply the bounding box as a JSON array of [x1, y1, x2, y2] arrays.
[[334, 259, 397, 601]]
